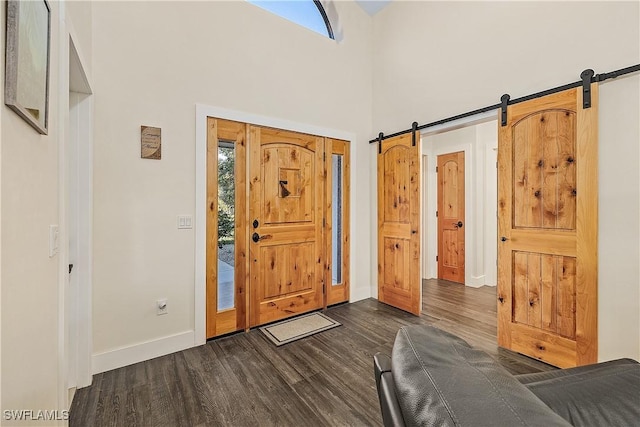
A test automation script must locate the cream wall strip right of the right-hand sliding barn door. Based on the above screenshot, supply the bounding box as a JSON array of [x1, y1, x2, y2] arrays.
[[598, 75, 640, 360]]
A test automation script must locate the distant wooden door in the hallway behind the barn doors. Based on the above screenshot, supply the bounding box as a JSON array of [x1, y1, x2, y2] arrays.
[[436, 151, 465, 283]]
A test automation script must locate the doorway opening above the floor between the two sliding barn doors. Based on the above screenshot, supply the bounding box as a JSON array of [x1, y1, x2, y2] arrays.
[[422, 115, 498, 287]]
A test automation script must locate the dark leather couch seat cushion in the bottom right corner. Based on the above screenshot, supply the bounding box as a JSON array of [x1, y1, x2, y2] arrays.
[[516, 359, 640, 426]]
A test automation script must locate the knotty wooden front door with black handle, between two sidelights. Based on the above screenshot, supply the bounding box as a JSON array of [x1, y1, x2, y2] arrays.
[[249, 126, 325, 326]]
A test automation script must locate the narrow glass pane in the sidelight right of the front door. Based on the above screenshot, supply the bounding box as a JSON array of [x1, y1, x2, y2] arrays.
[[331, 154, 344, 285]]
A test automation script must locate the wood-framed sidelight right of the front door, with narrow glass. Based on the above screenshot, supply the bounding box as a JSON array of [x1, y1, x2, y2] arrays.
[[325, 138, 350, 305]]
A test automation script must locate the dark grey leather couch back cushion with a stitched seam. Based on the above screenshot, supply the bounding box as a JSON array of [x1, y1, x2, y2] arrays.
[[391, 325, 570, 426]]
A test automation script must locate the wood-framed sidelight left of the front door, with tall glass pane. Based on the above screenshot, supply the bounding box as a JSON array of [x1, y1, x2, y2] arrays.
[[206, 117, 248, 338]]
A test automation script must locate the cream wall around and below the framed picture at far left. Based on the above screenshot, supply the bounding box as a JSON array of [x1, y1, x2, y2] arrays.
[[0, 2, 59, 422]]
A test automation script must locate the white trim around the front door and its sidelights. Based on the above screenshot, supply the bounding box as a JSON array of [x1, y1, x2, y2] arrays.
[[194, 104, 356, 345]]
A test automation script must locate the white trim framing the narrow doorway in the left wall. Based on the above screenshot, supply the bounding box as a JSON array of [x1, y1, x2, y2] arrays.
[[57, 7, 93, 409]]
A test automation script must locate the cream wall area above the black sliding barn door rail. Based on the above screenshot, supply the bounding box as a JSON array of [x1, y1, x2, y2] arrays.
[[372, 1, 640, 136]]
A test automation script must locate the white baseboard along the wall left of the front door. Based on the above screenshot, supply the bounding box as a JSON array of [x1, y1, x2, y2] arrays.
[[92, 331, 194, 375]]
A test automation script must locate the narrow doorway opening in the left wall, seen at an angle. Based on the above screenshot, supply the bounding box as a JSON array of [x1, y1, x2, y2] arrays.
[[65, 36, 93, 405]]
